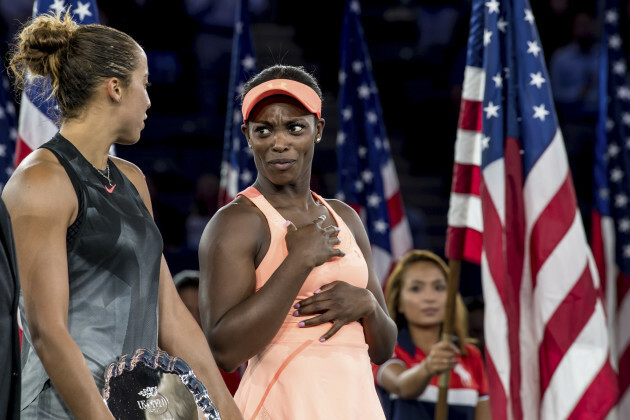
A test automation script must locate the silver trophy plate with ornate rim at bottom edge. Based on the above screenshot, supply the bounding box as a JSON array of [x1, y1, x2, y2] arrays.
[[103, 349, 221, 420]]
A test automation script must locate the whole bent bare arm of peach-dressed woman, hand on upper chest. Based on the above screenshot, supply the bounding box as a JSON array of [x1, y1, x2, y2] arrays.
[[199, 203, 342, 371]]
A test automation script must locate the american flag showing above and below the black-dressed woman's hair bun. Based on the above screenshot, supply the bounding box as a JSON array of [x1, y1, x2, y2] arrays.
[[15, 0, 98, 166]]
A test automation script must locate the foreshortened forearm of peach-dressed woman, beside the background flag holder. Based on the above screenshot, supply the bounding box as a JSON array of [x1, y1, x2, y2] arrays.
[[361, 291, 398, 364]]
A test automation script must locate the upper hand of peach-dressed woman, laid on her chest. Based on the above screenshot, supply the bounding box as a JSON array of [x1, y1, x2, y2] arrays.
[[285, 215, 345, 267]]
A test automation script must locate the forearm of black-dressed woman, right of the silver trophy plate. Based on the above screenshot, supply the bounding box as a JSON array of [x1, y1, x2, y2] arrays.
[[159, 305, 242, 419]]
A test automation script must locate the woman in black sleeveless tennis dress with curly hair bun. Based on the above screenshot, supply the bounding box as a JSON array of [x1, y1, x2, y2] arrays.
[[2, 14, 242, 419]]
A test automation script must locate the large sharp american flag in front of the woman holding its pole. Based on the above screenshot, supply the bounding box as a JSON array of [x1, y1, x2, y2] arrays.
[[447, 0, 617, 420]]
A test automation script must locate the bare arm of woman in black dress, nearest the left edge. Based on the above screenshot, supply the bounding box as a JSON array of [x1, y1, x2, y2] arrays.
[[2, 150, 113, 419]]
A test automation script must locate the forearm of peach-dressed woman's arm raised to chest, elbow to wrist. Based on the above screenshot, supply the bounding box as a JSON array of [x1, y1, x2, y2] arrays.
[[209, 256, 312, 371]]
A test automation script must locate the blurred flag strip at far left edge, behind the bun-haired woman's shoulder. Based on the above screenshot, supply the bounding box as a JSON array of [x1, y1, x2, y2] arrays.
[[0, 74, 17, 192]]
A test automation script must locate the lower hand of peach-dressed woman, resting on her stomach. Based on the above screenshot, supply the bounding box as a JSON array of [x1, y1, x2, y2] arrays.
[[293, 281, 377, 341]]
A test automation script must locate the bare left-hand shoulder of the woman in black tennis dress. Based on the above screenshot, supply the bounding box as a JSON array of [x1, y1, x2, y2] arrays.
[[2, 149, 78, 219]]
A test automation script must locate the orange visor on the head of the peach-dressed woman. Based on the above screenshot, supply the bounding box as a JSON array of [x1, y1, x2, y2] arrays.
[[241, 79, 322, 122]]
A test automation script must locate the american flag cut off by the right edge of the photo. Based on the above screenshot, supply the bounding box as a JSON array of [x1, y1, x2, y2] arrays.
[[592, 0, 630, 419]]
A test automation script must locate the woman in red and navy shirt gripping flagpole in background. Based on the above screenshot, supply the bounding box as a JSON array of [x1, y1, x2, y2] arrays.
[[373, 250, 490, 420]]
